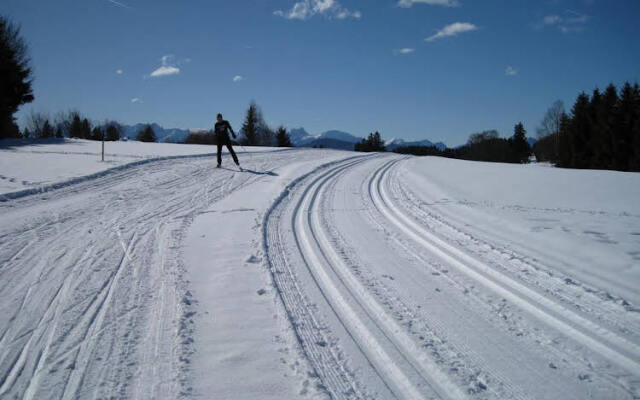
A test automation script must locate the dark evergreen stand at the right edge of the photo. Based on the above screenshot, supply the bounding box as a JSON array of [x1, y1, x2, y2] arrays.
[[533, 82, 640, 171]]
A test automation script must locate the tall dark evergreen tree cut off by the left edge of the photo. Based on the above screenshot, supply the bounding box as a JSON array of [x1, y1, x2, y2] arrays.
[[0, 16, 34, 139]]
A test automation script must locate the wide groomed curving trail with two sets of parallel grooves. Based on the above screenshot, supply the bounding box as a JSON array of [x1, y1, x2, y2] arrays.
[[264, 156, 640, 399]]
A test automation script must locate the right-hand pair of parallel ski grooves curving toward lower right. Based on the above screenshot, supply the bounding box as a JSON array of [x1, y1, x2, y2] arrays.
[[372, 156, 640, 396]]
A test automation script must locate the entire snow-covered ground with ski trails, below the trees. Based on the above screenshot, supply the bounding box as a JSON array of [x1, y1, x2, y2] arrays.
[[0, 142, 640, 399]]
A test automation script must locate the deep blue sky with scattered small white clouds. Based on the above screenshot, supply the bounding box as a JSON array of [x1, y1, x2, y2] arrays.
[[5, 0, 640, 145]]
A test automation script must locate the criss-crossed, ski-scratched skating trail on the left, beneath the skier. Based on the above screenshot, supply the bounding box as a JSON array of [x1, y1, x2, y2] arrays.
[[0, 151, 291, 399]]
